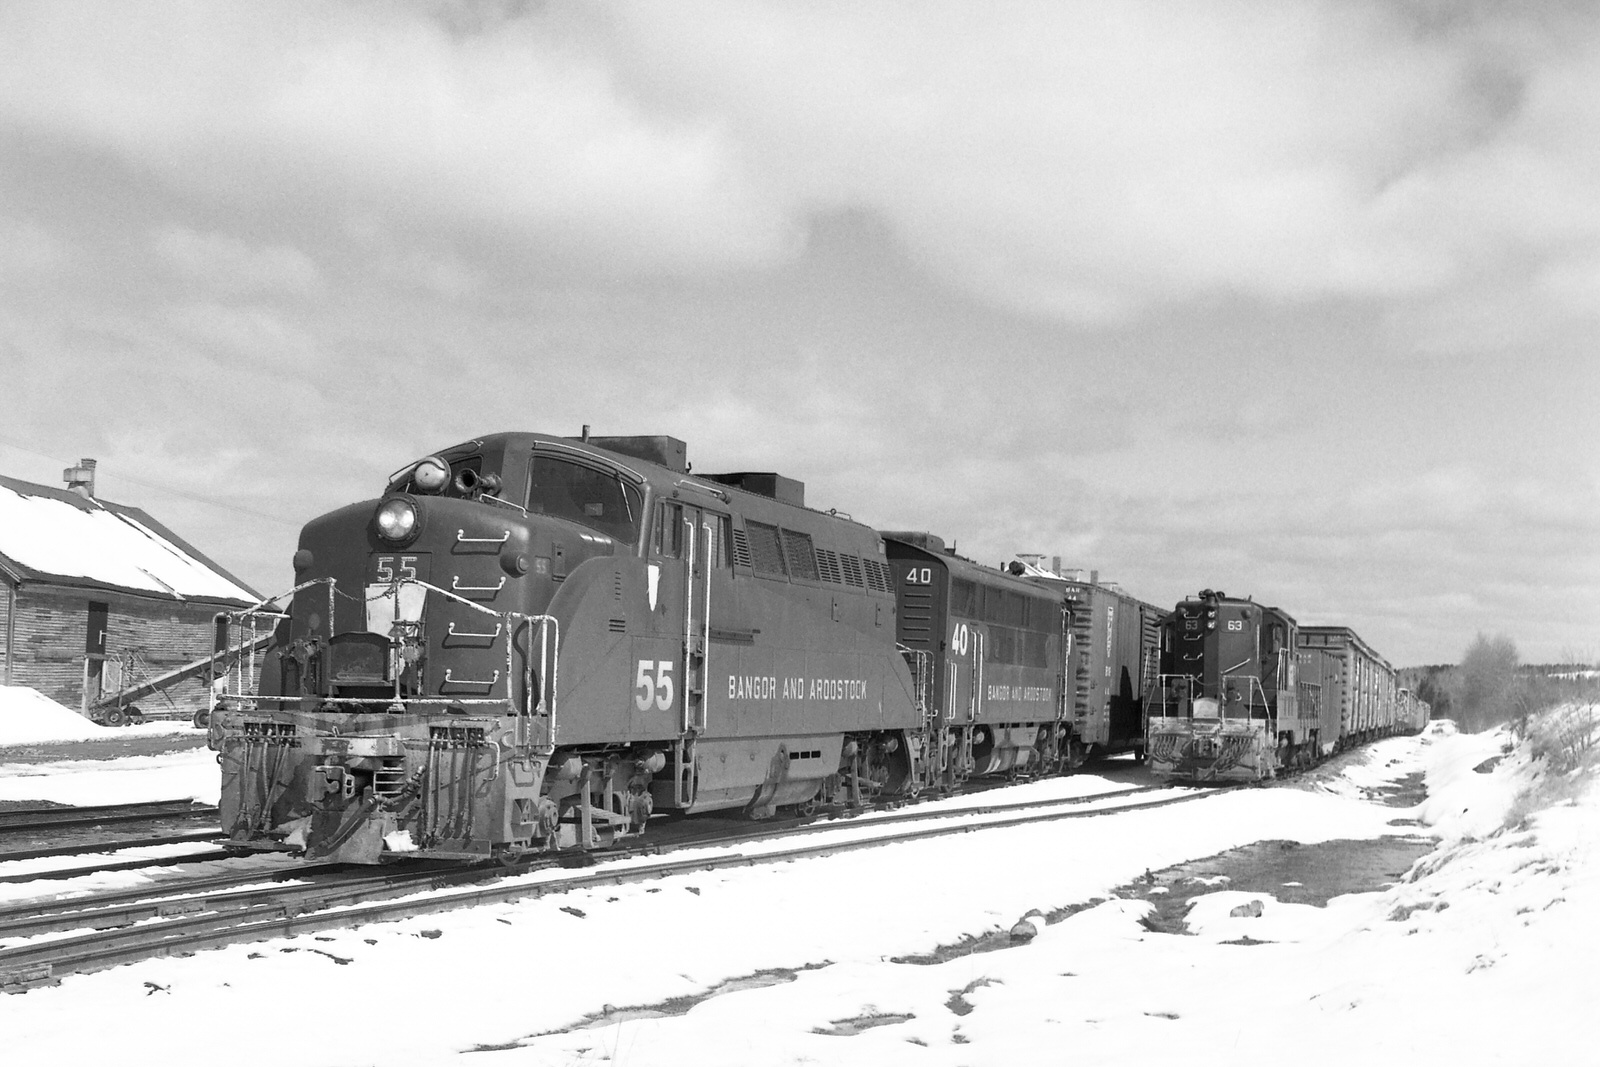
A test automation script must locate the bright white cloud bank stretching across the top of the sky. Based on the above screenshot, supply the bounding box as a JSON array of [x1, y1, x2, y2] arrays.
[[0, 0, 1600, 323]]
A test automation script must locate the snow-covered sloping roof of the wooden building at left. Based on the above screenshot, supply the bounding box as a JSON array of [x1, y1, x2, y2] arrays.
[[0, 477, 261, 603]]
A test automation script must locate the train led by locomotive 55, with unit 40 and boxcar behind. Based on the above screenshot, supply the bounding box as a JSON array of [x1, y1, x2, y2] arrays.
[[211, 432, 1420, 862]]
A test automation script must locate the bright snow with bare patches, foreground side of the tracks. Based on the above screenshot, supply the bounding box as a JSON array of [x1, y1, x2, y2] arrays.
[[0, 716, 1600, 1067]]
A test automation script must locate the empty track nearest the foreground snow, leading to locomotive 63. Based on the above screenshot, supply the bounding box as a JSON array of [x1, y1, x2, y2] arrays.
[[0, 785, 1224, 992]]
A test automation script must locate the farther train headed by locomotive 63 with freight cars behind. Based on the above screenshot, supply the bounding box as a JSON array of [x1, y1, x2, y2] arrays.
[[1146, 590, 1405, 782]]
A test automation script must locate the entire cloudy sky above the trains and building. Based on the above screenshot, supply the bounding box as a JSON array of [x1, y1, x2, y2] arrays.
[[0, 0, 1600, 665]]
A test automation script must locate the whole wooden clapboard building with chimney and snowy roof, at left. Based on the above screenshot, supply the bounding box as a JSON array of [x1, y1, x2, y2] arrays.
[[0, 459, 259, 713]]
